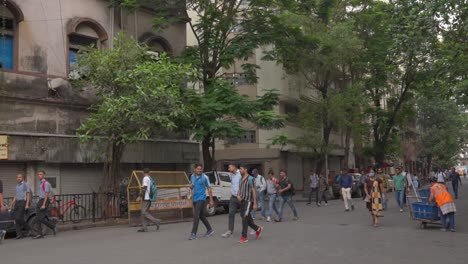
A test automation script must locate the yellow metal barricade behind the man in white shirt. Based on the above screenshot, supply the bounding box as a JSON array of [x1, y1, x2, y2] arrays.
[[127, 171, 193, 225]]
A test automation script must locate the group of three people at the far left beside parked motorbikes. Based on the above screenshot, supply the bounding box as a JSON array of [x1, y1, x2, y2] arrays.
[[0, 170, 57, 242]]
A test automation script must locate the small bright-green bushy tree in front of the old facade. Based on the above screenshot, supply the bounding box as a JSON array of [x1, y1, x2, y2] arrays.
[[75, 34, 193, 190]]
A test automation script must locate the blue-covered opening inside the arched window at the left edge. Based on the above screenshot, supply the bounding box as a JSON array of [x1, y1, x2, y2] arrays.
[[0, 7, 15, 70]]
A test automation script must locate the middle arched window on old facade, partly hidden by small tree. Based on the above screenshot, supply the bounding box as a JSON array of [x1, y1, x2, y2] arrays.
[[68, 18, 109, 74]]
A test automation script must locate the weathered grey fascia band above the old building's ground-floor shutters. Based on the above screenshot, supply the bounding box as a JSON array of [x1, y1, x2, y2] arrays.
[[8, 136, 199, 164]]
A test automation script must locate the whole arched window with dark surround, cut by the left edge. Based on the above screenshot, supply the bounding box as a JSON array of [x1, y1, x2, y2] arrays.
[[0, 0, 24, 70]]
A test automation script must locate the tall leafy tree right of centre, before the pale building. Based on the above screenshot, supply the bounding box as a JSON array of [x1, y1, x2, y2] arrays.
[[268, 0, 362, 170]]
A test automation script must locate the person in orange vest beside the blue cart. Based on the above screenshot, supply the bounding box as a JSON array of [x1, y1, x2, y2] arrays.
[[428, 179, 457, 232]]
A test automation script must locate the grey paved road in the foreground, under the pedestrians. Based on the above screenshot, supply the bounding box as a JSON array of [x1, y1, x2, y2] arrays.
[[0, 178, 468, 264]]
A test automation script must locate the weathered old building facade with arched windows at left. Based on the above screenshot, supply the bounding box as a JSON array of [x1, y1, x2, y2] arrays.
[[0, 0, 199, 196]]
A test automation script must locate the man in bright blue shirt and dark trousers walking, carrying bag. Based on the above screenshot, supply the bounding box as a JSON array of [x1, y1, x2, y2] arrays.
[[189, 164, 214, 240]]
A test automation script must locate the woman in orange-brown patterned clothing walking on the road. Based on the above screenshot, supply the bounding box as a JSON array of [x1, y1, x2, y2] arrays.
[[364, 172, 384, 227]]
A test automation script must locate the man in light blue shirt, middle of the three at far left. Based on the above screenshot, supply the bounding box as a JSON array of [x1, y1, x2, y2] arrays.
[[10, 173, 31, 239]]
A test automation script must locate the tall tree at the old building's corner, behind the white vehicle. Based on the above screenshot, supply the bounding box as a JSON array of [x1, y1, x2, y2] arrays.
[[113, 0, 284, 169]]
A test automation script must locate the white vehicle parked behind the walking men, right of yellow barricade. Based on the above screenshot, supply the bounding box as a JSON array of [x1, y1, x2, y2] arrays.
[[201, 171, 233, 216]]
